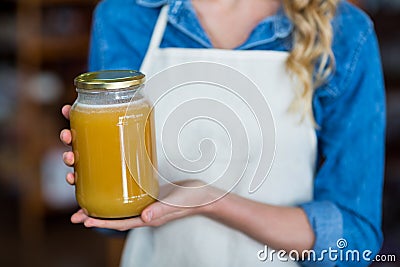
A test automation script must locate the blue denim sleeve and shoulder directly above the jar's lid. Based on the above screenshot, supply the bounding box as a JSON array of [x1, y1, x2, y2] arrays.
[[88, 0, 159, 71]]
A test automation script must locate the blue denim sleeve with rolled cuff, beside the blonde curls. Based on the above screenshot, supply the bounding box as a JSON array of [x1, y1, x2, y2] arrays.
[[301, 19, 385, 266]]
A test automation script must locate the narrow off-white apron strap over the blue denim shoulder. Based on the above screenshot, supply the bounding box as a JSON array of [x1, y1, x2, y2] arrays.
[[141, 5, 169, 73]]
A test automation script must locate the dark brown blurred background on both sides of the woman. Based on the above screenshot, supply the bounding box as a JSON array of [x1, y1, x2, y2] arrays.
[[0, 0, 400, 267]]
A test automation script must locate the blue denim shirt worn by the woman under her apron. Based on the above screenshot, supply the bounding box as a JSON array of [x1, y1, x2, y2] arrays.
[[89, 0, 385, 266]]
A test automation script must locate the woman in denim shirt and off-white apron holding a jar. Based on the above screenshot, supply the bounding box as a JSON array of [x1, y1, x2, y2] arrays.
[[61, 0, 385, 266]]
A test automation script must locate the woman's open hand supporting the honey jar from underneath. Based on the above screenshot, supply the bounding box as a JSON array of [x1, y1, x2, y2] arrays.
[[71, 180, 219, 231]]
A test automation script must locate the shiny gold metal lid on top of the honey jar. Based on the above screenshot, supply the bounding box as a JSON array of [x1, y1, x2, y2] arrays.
[[74, 70, 145, 90]]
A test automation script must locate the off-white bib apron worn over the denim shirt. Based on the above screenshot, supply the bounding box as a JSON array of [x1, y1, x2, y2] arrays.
[[122, 4, 316, 267]]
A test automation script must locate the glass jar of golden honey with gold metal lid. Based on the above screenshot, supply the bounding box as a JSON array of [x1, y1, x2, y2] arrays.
[[70, 70, 159, 218]]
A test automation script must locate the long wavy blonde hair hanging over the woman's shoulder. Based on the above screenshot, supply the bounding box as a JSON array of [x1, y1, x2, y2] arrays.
[[283, 0, 339, 123]]
